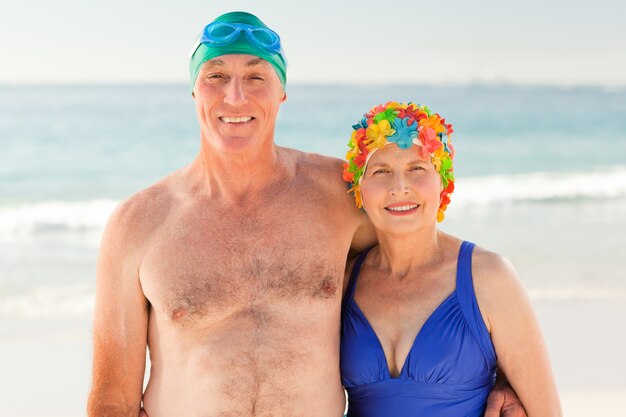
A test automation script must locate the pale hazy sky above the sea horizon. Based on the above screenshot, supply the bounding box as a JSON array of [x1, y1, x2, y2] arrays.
[[0, 0, 626, 87]]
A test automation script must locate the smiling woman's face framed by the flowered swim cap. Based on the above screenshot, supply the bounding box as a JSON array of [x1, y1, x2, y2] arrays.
[[360, 144, 442, 234]]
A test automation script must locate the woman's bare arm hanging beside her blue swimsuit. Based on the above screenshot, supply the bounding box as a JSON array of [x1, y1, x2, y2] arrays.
[[472, 248, 562, 417]]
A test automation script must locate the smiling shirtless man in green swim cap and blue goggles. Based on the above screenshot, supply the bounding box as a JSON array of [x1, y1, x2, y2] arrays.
[[88, 12, 520, 417]]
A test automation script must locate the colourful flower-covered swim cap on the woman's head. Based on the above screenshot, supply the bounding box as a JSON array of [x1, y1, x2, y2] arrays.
[[343, 101, 454, 222]]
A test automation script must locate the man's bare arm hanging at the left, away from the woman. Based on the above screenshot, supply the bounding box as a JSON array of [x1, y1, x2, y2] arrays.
[[87, 202, 149, 417]]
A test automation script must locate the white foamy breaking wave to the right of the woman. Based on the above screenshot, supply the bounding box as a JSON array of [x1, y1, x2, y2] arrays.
[[452, 167, 626, 206]]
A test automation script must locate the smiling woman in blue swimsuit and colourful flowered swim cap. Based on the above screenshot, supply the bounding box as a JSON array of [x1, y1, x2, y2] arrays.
[[341, 102, 561, 417]]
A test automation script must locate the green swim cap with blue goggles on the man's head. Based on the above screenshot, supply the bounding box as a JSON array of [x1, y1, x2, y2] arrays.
[[189, 12, 287, 91]]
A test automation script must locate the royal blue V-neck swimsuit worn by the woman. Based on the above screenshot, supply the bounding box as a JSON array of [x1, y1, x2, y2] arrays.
[[341, 242, 496, 417]]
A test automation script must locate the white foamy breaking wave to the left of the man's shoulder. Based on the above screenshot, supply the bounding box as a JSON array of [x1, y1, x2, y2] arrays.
[[0, 200, 118, 235]]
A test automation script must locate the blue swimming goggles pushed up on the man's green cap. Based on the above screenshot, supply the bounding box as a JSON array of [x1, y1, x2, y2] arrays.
[[200, 22, 282, 54]]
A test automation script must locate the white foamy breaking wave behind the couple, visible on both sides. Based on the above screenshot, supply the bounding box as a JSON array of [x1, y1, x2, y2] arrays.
[[0, 167, 626, 235]]
